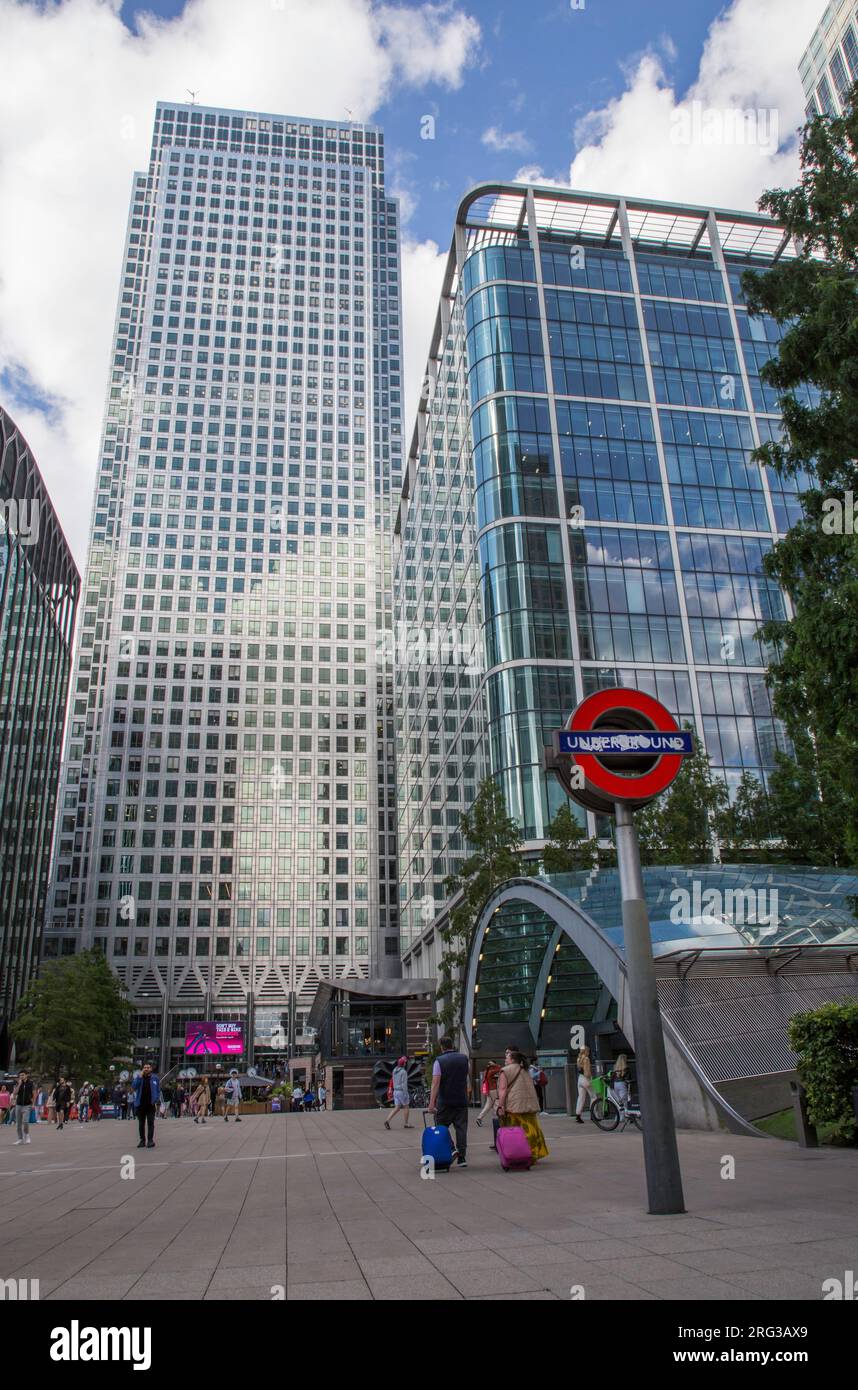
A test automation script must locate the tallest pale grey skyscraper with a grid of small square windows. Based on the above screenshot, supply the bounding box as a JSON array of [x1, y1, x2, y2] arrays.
[[49, 101, 402, 1063]]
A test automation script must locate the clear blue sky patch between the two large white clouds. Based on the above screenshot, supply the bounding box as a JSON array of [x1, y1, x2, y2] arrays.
[[116, 0, 728, 246]]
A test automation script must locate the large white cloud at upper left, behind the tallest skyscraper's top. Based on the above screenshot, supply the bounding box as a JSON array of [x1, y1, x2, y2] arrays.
[[0, 0, 480, 563]]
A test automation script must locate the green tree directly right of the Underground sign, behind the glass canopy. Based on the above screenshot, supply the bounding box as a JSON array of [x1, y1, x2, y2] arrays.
[[636, 726, 729, 865]]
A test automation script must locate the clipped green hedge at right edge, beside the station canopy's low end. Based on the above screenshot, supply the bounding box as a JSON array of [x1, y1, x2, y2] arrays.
[[787, 1002, 858, 1144]]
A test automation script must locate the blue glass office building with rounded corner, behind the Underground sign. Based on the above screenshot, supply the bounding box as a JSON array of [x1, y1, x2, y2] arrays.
[[395, 185, 797, 956]]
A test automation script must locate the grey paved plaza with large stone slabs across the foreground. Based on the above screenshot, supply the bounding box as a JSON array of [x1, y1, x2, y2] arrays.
[[0, 1111, 858, 1301]]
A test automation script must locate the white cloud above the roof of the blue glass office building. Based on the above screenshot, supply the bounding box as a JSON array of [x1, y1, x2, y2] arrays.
[[523, 0, 811, 210]]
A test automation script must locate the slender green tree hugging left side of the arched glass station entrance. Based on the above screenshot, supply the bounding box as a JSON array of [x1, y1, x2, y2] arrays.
[[434, 777, 531, 1027]]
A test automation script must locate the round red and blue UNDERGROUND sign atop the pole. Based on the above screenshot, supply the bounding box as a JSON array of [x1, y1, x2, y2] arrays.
[[548, 687, 694, 816]]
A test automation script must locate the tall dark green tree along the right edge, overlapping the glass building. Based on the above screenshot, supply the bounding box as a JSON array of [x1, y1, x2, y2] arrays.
[[744, 86, 858, 862]]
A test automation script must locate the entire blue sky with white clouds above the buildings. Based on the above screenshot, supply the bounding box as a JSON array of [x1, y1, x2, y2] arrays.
[[0, 0, 825, 563]]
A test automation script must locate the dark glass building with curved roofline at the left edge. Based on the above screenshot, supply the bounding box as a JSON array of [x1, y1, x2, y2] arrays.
[[0, 407, 81, 1065]]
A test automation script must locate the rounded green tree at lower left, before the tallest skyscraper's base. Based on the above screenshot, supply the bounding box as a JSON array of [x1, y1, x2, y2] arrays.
[[10, 951, 132, 1081]]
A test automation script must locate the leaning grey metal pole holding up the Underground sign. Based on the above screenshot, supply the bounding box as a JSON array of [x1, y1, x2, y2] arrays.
[[615, 801, 686, 1215]]
